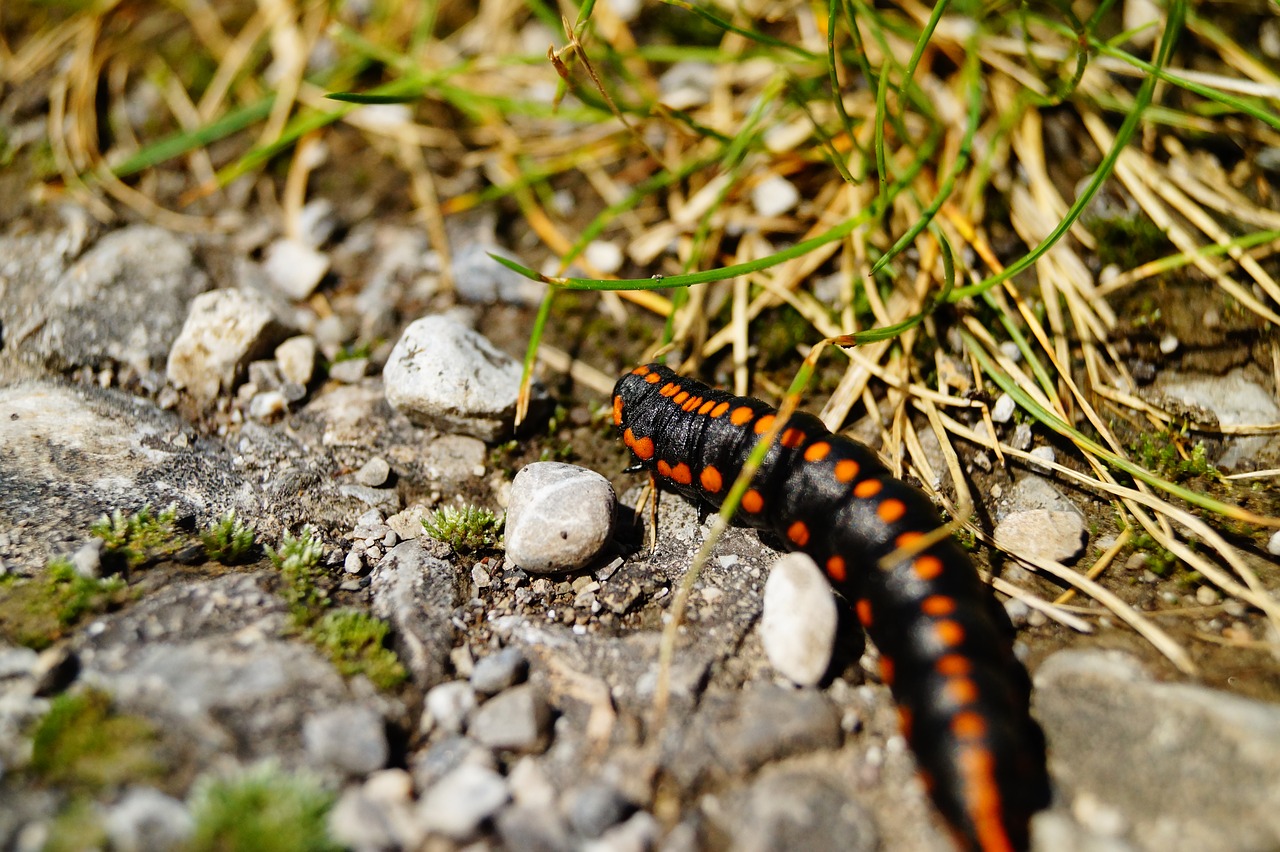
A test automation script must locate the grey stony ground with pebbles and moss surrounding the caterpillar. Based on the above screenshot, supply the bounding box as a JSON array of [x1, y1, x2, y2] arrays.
[[0, 205, 1280, 852]]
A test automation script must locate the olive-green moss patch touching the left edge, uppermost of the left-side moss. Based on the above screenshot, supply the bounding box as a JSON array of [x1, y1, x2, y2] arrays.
[[0, 559, 129, 651]]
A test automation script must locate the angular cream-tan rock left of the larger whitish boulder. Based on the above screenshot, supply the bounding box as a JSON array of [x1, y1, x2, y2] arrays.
[[168, 288, 282, 403]]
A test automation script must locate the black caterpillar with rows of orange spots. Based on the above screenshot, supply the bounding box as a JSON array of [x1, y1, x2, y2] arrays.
[[613, 363, 1048, 852]]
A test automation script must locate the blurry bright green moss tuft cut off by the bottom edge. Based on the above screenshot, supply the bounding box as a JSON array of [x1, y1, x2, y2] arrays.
[[187, 762, 342, 852]]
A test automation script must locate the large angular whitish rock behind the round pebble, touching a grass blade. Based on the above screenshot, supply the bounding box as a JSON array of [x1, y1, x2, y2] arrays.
[[373, 316, 547, 441]]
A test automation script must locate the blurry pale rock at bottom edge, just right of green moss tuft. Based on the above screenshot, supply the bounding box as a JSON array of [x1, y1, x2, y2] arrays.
[[329, 769, 425, 852]]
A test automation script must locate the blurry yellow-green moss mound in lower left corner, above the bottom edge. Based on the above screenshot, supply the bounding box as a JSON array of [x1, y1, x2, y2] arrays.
[[28, 690, 165, 791]]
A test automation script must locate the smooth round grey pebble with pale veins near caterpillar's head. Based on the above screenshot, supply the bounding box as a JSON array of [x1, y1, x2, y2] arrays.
[[506, 462, 617, 574]]
